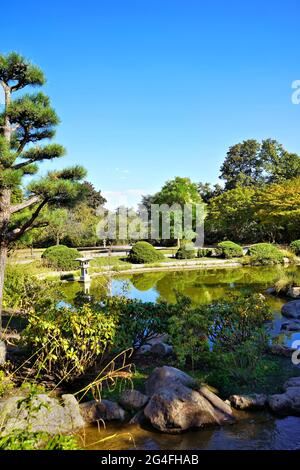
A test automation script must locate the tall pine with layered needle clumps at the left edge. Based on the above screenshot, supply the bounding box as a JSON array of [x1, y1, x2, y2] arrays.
[[0, 52, 85, 324]]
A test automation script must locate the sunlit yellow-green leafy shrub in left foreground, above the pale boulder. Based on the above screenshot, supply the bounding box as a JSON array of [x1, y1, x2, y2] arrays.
[[23, 304, 116, 381]]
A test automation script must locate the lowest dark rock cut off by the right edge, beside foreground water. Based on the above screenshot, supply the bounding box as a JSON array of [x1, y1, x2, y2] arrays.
[[268, 377, 300, 416]]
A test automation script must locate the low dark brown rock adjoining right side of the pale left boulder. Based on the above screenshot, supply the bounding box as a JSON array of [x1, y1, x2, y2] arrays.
[[80, 400, 125, 424]]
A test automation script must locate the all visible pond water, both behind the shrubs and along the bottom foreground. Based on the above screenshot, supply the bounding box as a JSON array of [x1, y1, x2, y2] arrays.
[[64, 267, 300, 450]]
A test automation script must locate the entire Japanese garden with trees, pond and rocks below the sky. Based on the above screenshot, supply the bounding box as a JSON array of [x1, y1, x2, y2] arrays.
[[0, 18, 300, 450]]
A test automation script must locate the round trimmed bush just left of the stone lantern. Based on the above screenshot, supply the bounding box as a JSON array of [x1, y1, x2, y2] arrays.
[[42, 245, 80, 271]]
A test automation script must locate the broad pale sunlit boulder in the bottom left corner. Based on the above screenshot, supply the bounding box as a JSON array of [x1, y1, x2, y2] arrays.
[[0, 394, 85, 435]]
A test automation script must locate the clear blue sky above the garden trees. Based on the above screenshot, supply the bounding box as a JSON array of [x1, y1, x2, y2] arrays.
[[0, 0, 300, 207]]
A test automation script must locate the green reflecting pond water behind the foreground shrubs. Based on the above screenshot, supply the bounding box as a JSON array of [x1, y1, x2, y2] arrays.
[[63, 266, 300, 346]]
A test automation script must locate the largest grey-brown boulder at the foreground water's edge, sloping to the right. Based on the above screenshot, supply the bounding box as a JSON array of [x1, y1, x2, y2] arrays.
[[144, 366, 233, 434]]
